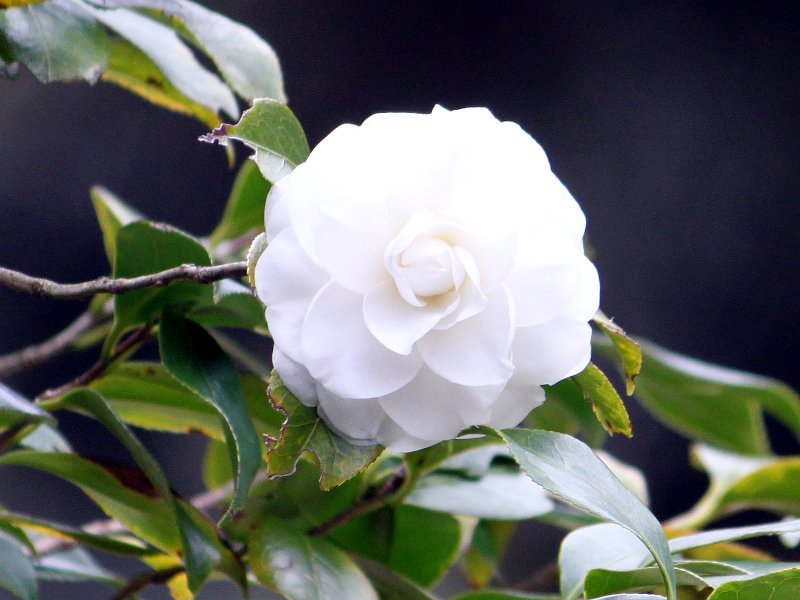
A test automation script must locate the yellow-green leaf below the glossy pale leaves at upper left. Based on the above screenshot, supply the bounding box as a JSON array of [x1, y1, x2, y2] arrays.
[[102, 38, 219, 127]]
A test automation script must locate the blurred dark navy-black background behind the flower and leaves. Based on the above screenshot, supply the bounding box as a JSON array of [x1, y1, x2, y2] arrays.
[[0, 0, 800, 597]]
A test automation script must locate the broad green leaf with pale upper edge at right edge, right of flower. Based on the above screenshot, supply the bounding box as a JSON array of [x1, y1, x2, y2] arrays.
[[624, 342, 800, 454]]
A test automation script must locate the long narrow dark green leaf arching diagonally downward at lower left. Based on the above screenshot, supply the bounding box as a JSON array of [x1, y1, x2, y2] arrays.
[[53, 390, 221, 591]]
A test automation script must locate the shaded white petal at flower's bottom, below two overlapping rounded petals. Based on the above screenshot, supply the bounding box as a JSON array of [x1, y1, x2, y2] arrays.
[[380, 367, 499, 440]]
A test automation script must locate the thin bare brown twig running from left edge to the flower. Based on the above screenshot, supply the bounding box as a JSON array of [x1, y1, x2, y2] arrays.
[[0, 261, 247, 300]]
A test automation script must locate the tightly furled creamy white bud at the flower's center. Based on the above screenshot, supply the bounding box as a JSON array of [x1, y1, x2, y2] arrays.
[[400, 237, 465, 298]]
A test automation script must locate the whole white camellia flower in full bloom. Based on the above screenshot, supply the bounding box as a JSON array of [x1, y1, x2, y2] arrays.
[[255, 107, 600, 452]]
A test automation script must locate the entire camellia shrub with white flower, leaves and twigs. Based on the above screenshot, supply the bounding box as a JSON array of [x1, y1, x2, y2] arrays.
[[0, 0, 800, 600]]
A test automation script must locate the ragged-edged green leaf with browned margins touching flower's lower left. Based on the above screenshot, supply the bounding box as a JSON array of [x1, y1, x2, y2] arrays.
[[267, 371, 383, 490]]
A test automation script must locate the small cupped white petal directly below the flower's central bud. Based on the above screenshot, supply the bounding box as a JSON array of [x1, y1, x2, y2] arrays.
[[364, 281, 457, 354]]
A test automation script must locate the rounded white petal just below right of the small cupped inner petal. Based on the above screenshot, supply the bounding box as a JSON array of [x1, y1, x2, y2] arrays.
[[417, 289, 514, 386]]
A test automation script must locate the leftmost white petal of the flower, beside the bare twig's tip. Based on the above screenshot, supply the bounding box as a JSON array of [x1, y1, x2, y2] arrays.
[[255, 229, 330, 362]]
